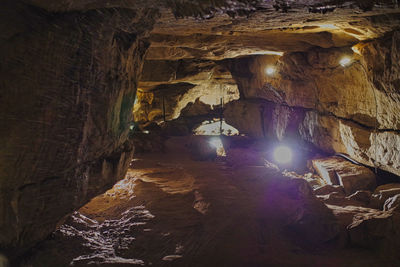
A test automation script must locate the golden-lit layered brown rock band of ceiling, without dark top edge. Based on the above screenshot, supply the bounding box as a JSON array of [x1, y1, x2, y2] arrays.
[[148, 1, 399, 59]]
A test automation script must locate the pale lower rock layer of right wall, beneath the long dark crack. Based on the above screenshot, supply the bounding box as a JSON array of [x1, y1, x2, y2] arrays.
[[299, 111, 400, 178]]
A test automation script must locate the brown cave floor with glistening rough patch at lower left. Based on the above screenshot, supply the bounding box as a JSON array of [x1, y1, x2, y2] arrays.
[[22, 139, 388, 266]]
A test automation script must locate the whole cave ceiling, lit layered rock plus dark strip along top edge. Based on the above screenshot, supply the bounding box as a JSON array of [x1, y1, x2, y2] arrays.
[[20, 0, 400, 60]]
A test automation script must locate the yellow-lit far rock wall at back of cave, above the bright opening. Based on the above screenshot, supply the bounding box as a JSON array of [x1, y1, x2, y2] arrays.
[[134, 59, 240, 123]]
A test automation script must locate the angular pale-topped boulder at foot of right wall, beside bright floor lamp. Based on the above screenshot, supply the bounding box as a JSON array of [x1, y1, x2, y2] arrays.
[[312, 157, 376, 195]]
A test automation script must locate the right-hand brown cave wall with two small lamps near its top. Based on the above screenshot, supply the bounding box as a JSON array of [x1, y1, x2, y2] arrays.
[[225, 31, 400, 175]]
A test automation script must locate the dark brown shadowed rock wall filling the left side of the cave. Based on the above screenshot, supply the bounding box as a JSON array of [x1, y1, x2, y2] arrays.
[[0, 1, 156, 256]]
